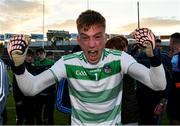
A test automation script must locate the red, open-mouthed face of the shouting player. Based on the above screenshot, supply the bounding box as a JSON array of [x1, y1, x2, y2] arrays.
[[77, 25, 106, 64]]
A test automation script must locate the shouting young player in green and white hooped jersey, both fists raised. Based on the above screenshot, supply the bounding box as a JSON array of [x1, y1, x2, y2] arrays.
[[8, 10, 166, 125]]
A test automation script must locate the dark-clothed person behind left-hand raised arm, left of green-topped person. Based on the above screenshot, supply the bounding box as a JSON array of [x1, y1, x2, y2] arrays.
[[13, 49, 35, 125]]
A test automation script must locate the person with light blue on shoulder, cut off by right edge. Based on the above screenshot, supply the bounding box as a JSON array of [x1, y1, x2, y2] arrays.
[[167, 32, 180, 125]]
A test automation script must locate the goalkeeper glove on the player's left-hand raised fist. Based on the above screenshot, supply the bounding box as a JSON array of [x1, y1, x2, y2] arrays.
[[7, 35, 31, 67]]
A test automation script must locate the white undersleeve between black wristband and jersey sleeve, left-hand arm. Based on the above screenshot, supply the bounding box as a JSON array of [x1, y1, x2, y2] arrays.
[[16, 70, 55, 96]]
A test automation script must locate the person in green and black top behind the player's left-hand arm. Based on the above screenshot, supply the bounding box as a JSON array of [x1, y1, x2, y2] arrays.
[[34, 48, 56, 125]]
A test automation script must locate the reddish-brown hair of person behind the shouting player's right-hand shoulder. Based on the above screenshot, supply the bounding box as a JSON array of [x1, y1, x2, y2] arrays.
[[106, 35, 128, 50]]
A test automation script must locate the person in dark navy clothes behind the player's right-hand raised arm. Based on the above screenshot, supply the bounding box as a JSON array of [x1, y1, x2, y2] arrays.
[[136, 39, 172, 125]]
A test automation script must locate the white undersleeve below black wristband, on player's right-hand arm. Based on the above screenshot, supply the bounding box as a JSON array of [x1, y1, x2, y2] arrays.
[[128, 63, 166, 90]]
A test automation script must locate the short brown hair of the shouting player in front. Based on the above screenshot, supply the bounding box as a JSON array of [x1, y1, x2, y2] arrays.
[[76, 10, 106, 31]]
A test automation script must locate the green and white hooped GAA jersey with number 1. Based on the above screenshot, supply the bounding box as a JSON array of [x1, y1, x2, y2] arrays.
[[51, 49, 136, 125]]
